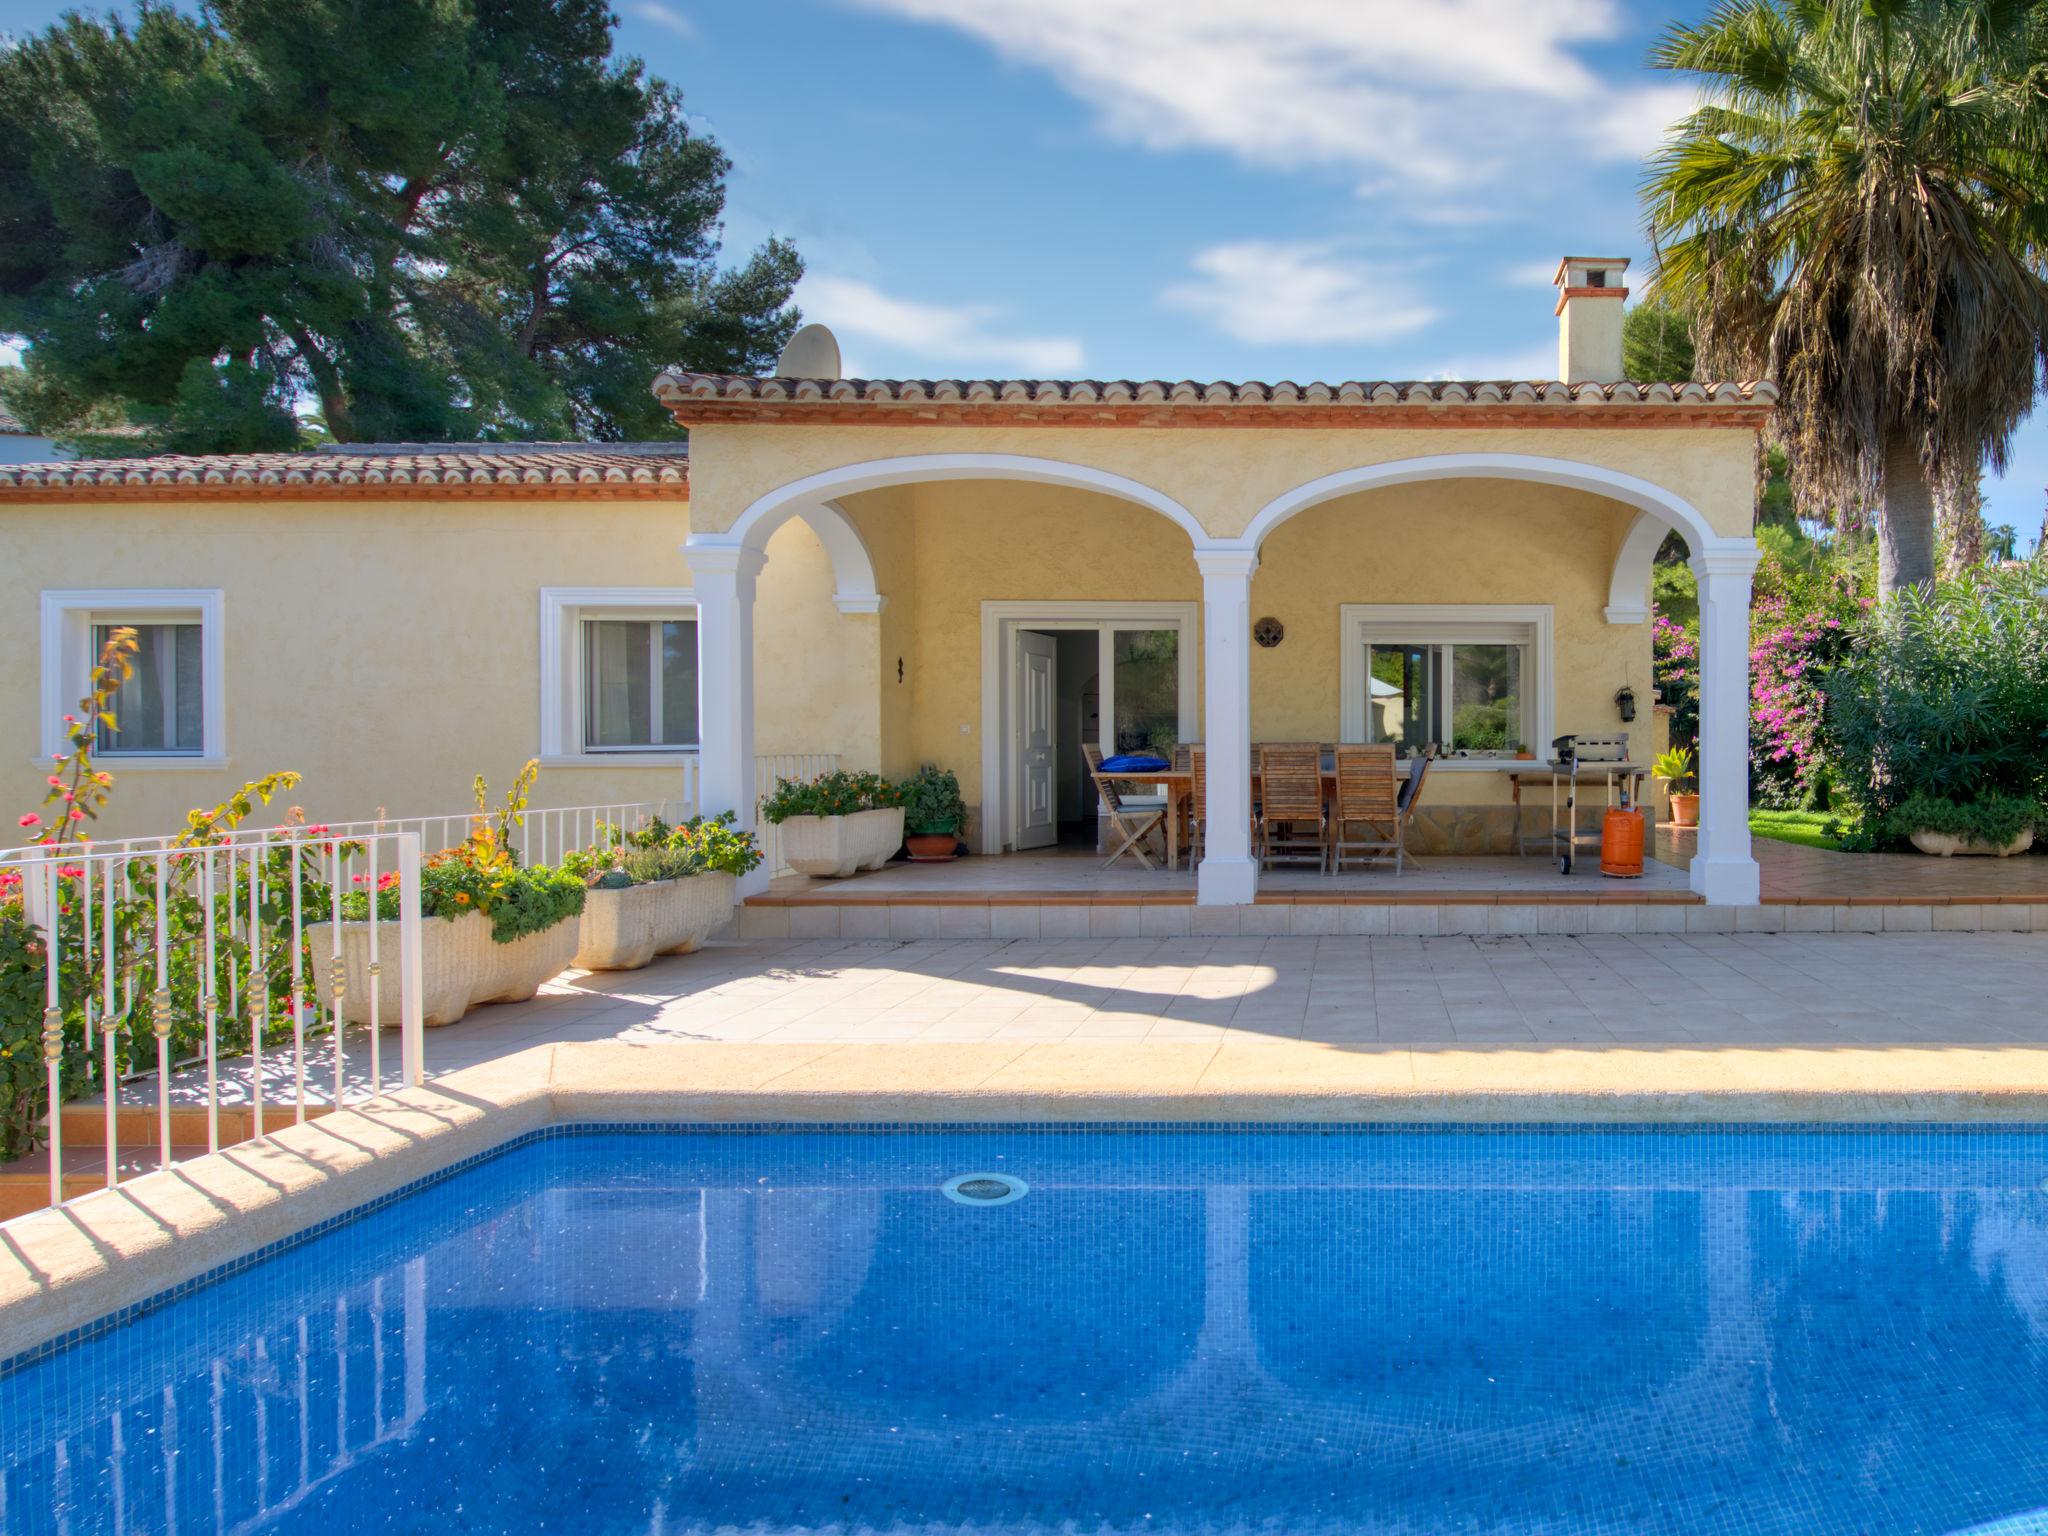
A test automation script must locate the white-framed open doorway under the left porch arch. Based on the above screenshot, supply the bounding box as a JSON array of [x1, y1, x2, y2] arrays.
[[983, 602, 1198, 852]]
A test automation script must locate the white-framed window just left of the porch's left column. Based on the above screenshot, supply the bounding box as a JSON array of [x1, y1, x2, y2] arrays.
[[541, 586, 698, 766]]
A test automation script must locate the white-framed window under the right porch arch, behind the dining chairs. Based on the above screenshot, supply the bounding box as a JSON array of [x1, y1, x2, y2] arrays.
[[1341, 604, 1550, 762]]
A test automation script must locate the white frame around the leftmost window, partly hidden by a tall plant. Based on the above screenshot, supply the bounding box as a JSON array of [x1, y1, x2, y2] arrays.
[[37, 588, 227, 770]]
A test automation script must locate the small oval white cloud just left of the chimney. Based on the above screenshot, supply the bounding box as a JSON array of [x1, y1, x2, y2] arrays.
[[1161, 240, 1438, 344]]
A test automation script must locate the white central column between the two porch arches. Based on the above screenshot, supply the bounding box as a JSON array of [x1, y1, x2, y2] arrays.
[[1194, 549, 1260, 907]]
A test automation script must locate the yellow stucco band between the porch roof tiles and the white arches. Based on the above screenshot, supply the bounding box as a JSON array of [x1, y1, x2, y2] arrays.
[[690, 416, 1755, 539]]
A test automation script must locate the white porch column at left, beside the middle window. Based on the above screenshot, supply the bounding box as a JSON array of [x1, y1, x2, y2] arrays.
[[684, 543, 768, 895]]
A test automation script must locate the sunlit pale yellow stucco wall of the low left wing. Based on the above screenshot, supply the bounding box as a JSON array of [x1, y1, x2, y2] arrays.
[[0, 500, 879, 842]]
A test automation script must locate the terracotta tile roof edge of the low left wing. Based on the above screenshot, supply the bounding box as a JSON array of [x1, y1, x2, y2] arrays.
[[0, 442, 690, 500]]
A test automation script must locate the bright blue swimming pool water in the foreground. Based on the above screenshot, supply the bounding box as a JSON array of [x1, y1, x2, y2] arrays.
[[0, 1128, 2048, 1536]]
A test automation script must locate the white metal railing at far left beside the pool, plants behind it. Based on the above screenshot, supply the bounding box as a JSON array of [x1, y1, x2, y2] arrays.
[[0, 827, 424, 1228]]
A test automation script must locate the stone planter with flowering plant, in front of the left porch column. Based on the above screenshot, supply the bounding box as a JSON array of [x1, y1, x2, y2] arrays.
[[563, 811, 762, 971]]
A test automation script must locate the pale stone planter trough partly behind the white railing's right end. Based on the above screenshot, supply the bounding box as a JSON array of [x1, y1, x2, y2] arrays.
[[305, 911, 578, 1028]]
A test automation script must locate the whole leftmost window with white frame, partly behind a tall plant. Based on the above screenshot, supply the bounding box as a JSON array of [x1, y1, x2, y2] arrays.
[[41, 588, 227, 768]]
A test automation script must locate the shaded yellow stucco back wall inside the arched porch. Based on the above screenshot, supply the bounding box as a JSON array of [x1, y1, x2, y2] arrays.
[[823, 479, 1651, 823]]
